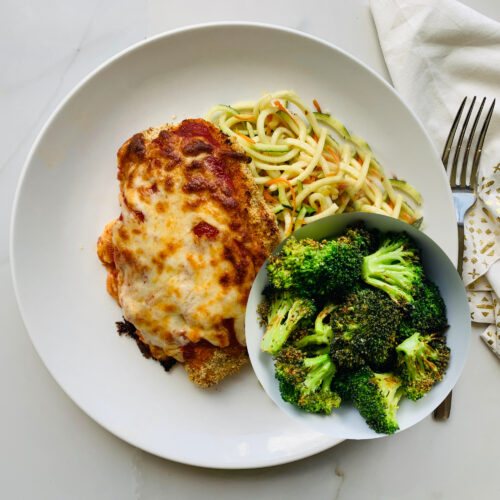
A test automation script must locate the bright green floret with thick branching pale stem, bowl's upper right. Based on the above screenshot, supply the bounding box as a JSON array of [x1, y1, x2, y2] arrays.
[[362, 233, 423, 305]]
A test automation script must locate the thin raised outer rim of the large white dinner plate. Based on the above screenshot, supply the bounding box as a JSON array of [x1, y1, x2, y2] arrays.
[[9, 21, 457, 470]]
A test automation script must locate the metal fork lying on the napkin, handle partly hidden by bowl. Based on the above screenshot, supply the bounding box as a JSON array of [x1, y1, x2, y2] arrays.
[[434, 97, 495, 420]]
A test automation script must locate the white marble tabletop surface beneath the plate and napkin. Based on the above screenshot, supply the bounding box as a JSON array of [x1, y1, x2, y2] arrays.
[[0, 0, 500, 500]]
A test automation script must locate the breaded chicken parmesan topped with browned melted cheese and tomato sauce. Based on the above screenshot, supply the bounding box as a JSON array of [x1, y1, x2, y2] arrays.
[[97, 119, 279, 387]]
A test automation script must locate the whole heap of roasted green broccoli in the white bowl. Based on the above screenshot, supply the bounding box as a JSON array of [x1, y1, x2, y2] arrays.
[[259, 223, 450, 434]]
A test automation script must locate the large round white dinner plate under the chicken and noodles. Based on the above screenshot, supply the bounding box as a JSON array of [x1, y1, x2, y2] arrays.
[[11, 24, 456, 468]]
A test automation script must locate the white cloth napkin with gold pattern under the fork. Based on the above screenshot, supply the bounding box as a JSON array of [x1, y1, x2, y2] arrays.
[[370, 0, 500, 357]]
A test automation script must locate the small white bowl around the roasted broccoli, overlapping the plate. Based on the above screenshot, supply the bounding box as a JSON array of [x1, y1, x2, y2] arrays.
[[245, 213, 470, 439]]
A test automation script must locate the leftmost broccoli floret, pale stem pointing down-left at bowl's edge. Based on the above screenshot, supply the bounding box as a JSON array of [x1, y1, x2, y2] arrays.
[[259, 291, 316, 354]]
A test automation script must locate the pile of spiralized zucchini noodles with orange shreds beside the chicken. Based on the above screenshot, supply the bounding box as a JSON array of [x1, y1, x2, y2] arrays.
[[206, 90, 422, 238]]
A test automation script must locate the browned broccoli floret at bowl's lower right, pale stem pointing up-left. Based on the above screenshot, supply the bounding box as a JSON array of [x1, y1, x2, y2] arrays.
[[396, 332, 450, 401]]
